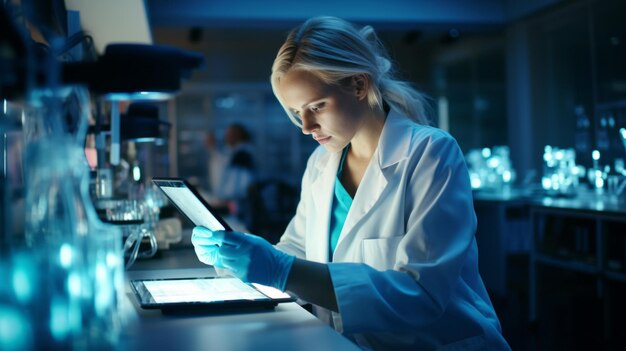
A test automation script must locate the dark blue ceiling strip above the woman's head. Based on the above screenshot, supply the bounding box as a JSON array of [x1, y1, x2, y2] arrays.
[[146, 0, 557, 29]]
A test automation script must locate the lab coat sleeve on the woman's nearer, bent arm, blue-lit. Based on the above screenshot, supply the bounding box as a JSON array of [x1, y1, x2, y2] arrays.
[[329, 137, 476, 333]]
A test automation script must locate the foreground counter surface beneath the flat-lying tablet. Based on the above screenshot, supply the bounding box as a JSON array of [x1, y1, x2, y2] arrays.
[[121, 238, 359, 351]]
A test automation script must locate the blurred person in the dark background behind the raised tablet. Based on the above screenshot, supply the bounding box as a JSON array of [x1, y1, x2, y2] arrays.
[[206, 123, 256, 214]]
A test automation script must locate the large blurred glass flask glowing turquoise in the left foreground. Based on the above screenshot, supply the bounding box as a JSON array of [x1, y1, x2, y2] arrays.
[[19, 87, 123, 350]]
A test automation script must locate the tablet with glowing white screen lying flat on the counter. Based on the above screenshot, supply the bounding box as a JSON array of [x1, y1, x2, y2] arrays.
[[130, 277, 296, 312]]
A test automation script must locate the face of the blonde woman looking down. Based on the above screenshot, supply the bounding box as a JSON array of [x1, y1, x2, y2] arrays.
[[277, 70, 369, 152]]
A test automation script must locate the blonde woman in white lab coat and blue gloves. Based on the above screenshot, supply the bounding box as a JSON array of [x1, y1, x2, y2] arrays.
[[192, 17, 509, 350]]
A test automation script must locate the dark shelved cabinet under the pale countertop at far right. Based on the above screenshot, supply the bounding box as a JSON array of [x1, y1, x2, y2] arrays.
[[529, 199, 626, 347]]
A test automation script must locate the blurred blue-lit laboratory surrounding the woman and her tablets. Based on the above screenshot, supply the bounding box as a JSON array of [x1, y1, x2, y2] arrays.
[[0, 0, 626, 350]]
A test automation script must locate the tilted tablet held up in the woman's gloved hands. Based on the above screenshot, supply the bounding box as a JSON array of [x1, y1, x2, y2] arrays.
[[152, 178, 232, 231]]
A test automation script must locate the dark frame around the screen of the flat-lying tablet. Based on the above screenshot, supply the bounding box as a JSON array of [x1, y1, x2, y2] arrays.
[[130, 277, 296, 311]]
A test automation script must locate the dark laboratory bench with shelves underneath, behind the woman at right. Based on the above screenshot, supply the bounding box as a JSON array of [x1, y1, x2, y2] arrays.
[[474, 189, 626, 349]]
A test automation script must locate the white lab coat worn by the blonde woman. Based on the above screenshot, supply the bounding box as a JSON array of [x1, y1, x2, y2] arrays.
[[276, 110, 510, 350]]
